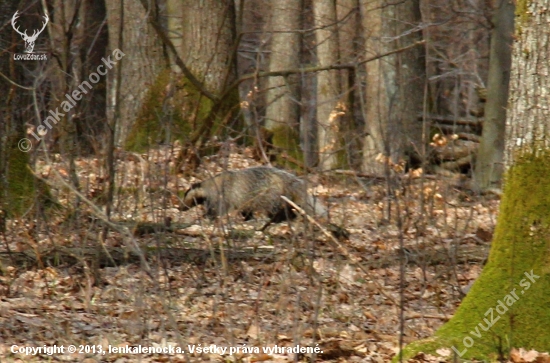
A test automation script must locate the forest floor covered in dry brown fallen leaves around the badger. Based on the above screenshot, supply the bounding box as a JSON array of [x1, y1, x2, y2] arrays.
[[0, 148, 508, 363]]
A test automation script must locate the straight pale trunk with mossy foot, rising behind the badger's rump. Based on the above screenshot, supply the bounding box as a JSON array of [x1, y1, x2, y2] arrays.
[[265, 0, 302, 166]]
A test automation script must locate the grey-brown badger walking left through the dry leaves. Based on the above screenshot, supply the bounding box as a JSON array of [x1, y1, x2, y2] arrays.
[[182, 166, 327, 222]]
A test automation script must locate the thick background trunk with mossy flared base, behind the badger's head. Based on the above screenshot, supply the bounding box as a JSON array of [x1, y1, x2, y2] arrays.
[[132, 0, 240, 162]]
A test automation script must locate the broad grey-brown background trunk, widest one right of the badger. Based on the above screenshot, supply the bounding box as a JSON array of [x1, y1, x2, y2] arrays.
[[360, 0, 425, 174]]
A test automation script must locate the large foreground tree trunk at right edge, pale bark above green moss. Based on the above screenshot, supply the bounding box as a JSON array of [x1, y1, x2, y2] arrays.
[[405, 0, 550, 360]]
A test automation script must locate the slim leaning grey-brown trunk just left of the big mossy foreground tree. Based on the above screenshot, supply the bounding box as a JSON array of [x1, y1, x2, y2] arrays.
[[473, 0, 515, 191]]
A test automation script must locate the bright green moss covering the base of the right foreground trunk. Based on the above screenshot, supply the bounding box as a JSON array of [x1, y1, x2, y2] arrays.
[[404, 152, 550, 361]]
